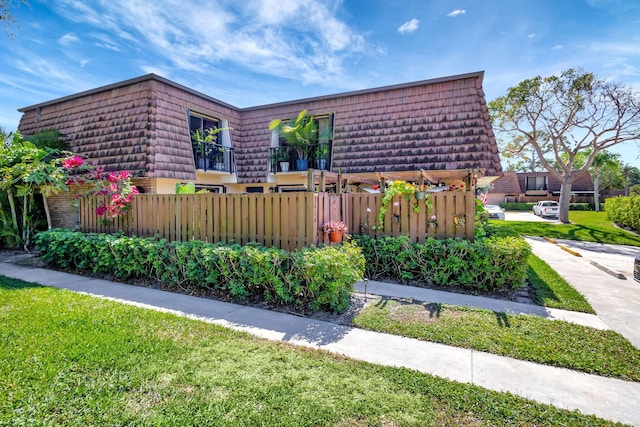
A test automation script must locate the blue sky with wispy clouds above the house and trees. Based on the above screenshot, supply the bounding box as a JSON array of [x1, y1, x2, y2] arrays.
[[0, 0, 640, 167]]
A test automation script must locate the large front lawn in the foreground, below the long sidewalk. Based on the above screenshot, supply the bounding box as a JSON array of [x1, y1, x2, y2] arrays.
[[0, 276, 622, 426]]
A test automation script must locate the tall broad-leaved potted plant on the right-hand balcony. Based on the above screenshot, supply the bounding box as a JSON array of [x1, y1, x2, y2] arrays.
[[269, 110, 318, 170]]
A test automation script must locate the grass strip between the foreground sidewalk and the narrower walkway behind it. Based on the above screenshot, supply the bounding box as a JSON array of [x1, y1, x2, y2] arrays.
[[353, 299, 640, 381]]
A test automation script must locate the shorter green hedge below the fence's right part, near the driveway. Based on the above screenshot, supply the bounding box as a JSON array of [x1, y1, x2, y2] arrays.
[[355, 236, 531, 292]]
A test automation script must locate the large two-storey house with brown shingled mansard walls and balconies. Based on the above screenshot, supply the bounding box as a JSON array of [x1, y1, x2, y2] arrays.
[[19, 72, 502, 229]]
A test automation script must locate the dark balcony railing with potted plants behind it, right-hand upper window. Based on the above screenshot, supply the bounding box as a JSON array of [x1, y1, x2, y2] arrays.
[[269, 143, 331, 173]]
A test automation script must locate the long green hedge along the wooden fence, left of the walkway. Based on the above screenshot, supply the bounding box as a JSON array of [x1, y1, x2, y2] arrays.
[[36, 230, 364, 311]]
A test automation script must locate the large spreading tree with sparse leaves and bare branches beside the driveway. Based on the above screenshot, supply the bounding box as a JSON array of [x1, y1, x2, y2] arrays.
[[489, 69, 640, 223]]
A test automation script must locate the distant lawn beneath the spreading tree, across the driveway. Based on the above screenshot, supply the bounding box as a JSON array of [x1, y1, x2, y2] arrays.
[[498, 211, 640, 246]]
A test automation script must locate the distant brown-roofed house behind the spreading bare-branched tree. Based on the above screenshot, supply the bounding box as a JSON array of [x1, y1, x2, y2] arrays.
[[487, 171, 594, 204]]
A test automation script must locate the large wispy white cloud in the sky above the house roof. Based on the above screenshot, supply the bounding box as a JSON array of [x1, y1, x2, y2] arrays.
[[50, 0, 373, 83]]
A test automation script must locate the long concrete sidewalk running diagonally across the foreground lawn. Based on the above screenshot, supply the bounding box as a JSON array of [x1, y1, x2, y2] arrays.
[[0, 263, 640, 425]]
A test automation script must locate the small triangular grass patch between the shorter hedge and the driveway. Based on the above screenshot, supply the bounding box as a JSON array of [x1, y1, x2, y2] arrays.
[[527, 254, 596, 314]]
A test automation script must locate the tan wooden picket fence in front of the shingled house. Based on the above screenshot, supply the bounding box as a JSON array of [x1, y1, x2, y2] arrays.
[[79, 192, 474, 250]]
